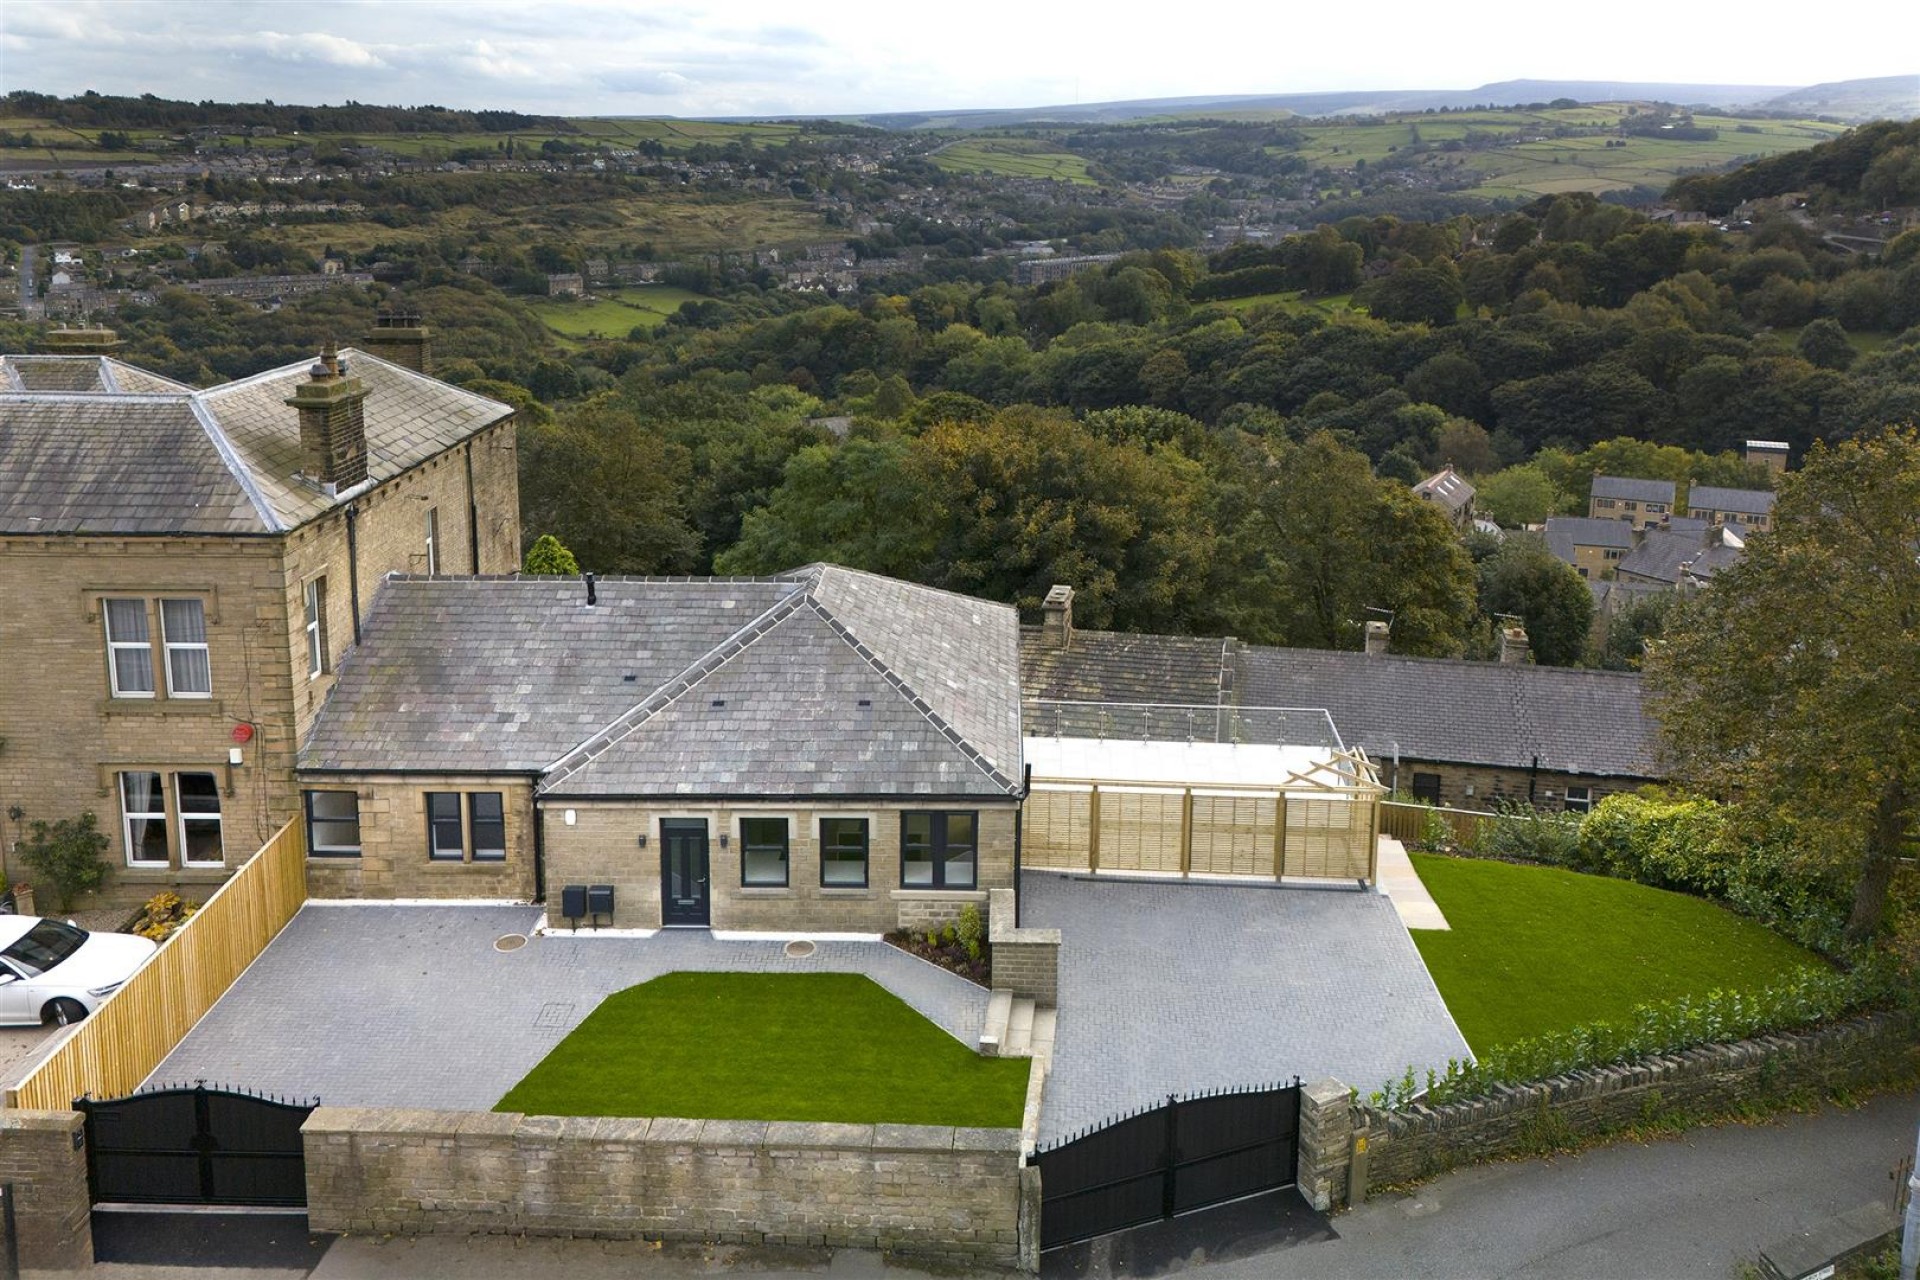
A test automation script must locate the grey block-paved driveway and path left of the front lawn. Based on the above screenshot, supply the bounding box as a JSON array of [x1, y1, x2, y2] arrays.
[[150, 904, 987, 1111]]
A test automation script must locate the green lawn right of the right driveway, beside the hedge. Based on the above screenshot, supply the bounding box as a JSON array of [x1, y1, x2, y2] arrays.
[[1411, 854, 1824, 1054]]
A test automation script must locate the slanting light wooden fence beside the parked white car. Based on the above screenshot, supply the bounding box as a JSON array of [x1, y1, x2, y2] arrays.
[[6, 819, 307, 1111]]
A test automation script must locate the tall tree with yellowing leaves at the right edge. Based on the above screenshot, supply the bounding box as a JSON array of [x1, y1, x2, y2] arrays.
[[1647, 426, 1920, 942]]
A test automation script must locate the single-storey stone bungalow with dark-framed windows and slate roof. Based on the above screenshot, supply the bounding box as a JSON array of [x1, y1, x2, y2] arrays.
[[300, 564, 1023, 933]]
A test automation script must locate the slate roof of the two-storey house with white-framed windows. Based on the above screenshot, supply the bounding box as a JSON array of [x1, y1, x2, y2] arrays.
[[0, 351, 513, 535]]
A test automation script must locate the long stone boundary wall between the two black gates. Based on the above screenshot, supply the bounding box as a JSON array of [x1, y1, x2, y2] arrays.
[[301, 1107, 1021, 1267]]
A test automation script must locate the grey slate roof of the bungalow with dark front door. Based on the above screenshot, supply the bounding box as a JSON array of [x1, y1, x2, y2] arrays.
[[300, 566, 1021, 796]]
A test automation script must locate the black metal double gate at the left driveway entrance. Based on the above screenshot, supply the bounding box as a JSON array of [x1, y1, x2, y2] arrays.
[[73, 1084, 319, 1207]]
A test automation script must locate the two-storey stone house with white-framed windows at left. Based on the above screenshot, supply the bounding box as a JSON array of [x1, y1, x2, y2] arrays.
[[0, 330, 520, 904]]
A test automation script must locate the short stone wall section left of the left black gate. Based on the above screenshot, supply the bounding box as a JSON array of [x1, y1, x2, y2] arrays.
[[0, 1111, 94, 1272]]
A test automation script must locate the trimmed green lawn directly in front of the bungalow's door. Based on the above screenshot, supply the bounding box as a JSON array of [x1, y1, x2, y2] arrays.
[[493, 973, 1027, 1128]]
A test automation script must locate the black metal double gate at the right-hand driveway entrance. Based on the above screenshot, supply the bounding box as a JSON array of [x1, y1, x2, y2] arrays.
[[1033, 1080, 1300, 1249]]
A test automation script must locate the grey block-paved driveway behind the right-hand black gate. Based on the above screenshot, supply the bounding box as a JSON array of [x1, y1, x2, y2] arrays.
[[1020, 871, 1469, 1142]]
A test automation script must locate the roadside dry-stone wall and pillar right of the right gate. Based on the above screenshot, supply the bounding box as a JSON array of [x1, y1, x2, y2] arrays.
[[1300, 1013, 1920, 1188]]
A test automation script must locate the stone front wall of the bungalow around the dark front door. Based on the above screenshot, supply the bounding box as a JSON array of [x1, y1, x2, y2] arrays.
[[540, 800, 1016, 933]]
